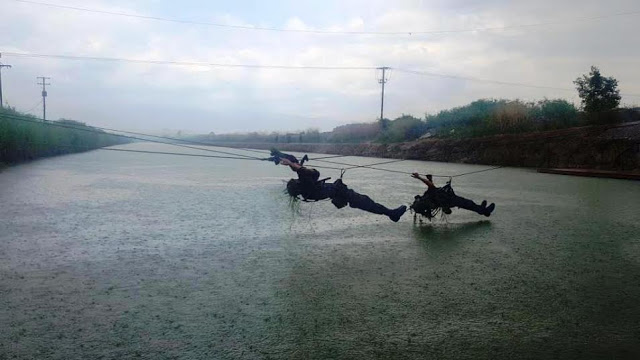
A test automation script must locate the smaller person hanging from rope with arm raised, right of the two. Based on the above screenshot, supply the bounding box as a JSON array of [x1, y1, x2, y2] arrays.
[[410, 173, 496, 220]]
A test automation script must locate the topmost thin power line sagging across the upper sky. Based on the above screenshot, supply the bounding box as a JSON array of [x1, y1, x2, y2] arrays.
[[14, 0, 640, 36]]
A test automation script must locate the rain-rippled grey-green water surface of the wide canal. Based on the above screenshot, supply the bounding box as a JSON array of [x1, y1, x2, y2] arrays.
[[0, 144, 640, 359]]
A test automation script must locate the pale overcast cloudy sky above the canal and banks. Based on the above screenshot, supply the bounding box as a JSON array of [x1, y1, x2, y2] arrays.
[[0, 0, 640, 133]]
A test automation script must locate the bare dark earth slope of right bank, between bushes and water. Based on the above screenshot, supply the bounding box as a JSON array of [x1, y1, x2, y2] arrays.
[[220, 122, 640, 172]]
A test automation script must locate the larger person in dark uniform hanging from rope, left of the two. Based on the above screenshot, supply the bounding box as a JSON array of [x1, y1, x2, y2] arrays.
[[279, 157, 407, 222]]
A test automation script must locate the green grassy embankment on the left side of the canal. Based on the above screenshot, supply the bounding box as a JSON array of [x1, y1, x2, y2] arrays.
[[0, 109, 126, 167]]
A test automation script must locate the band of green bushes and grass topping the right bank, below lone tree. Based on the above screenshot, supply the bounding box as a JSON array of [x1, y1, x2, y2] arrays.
[[195, 99, 640, 144]]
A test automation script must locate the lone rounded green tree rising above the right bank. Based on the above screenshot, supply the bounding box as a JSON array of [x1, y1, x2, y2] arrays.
[[573, 66, 620, 113]]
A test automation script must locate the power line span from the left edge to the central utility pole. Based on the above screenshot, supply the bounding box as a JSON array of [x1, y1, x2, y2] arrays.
[[3, 51, 376, 70]]
